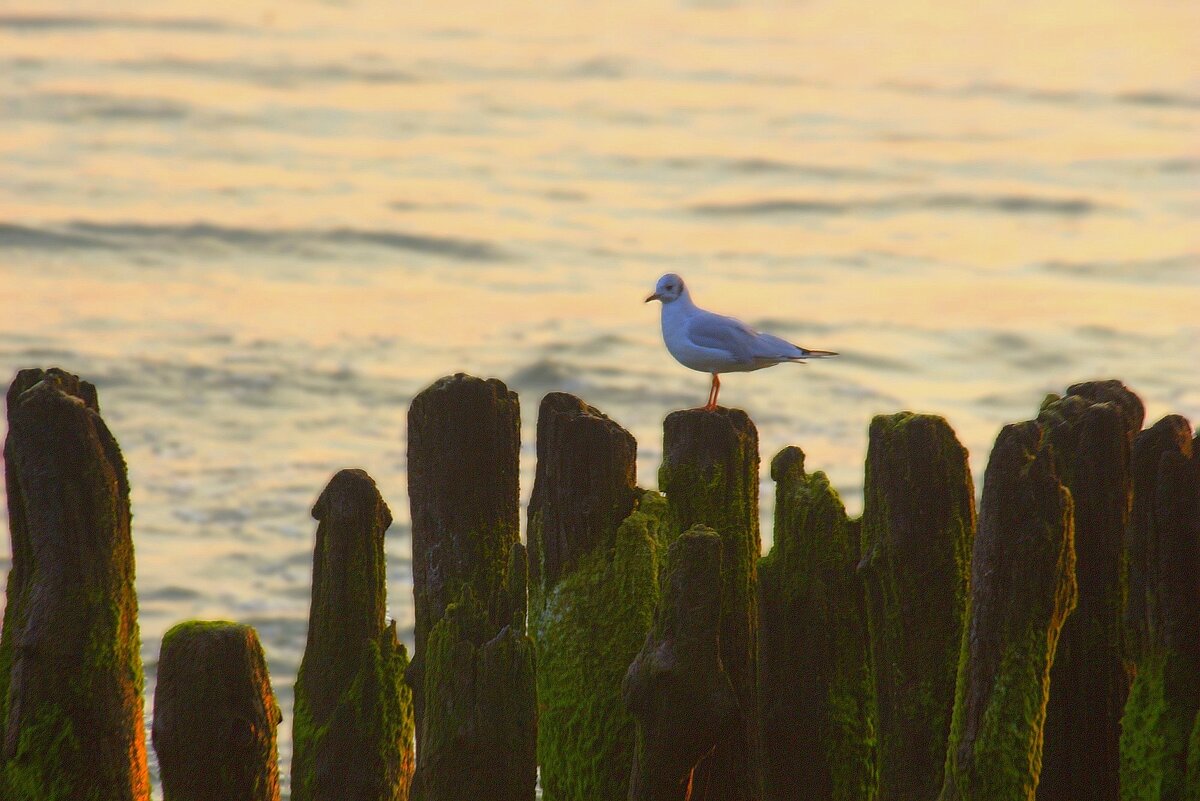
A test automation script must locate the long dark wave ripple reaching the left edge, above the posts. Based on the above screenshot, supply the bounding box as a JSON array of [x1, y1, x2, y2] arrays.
[[0, 221, 504, 261]]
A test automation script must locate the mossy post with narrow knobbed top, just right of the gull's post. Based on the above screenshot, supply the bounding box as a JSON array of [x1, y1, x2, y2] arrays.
[[758, 447, 875, 801]]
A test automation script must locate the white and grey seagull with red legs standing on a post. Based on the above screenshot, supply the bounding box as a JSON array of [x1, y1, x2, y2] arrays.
[[646, 272, 838, 411]]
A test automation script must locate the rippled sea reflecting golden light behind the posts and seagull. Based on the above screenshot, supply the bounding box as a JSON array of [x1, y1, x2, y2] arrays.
[[0, 0, 1200, 796]]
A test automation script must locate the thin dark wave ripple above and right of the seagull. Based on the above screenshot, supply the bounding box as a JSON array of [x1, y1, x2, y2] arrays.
[[690, 193, 1103, 217]]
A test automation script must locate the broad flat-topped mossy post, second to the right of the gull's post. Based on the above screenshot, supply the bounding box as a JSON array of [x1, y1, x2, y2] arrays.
[[859, 412, 974, 801]]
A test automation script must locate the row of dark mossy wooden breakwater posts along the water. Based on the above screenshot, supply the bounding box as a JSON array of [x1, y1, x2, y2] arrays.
[[0, 369, 1200, 801]]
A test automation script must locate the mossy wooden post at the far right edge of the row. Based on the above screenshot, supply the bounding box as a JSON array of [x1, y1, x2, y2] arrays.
[[1121, 415, 1200, 801]]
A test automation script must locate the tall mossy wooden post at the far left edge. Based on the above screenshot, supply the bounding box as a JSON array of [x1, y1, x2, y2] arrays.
[[0, 369, 150, 801]]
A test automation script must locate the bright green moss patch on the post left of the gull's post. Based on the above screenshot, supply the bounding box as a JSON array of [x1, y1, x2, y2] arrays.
[[532, 493, 659, 801]]
